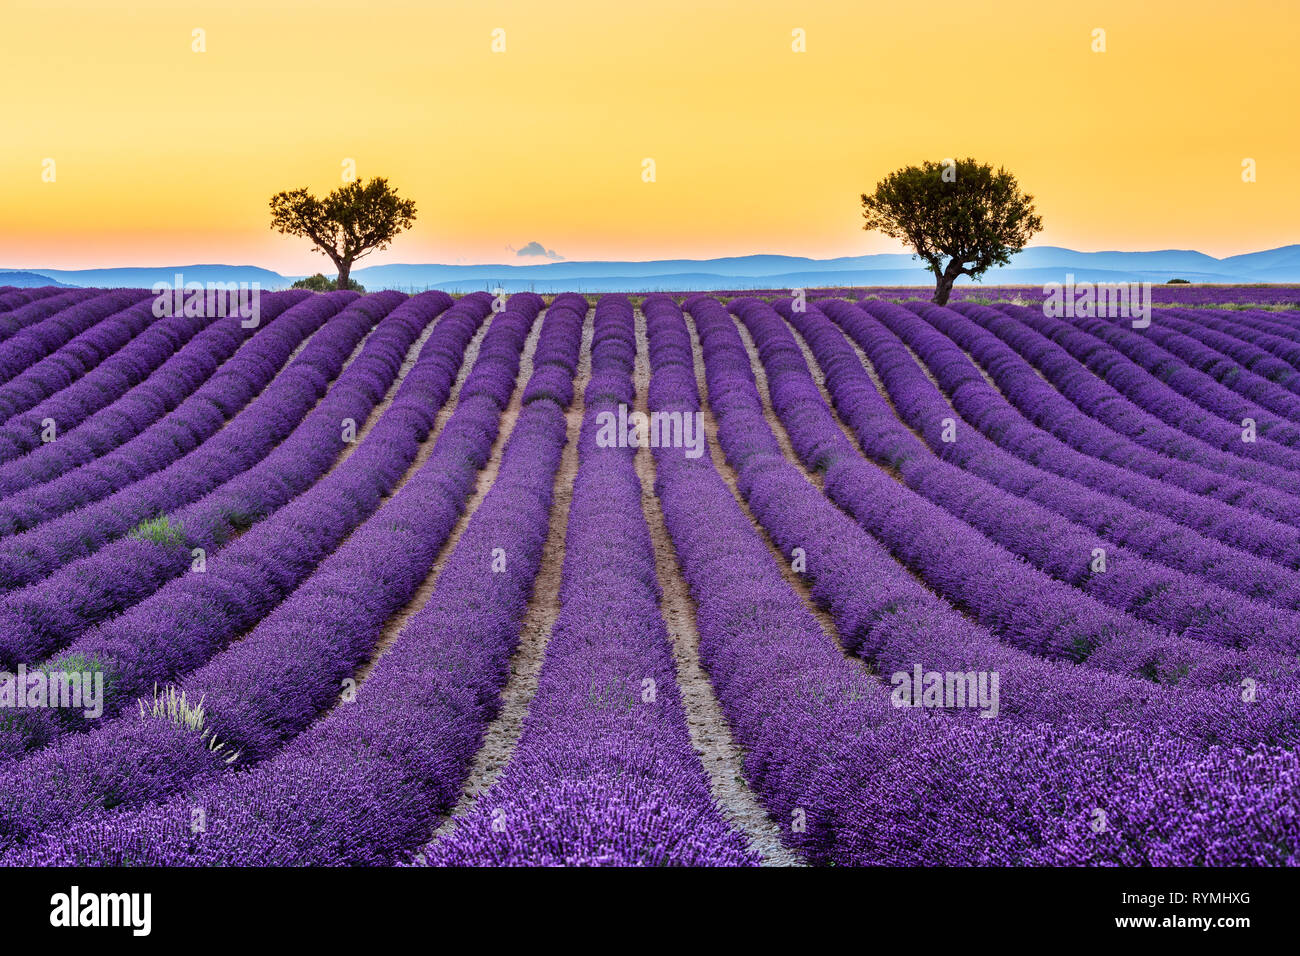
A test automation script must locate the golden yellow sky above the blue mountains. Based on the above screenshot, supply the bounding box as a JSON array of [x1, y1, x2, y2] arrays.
[[0, 0, 1300, 272]]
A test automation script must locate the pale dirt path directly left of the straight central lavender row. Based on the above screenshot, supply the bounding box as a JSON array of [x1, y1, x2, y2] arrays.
[[432, 310, 595, 840]]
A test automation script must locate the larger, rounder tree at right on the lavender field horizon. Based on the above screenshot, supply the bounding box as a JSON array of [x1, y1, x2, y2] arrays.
[[862, 159, 1043, 306]]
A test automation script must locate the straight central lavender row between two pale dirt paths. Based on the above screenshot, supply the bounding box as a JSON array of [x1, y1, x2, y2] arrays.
[[423, 295, 757, 866]]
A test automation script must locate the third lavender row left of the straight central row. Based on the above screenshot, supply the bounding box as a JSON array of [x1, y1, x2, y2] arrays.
[[0, 293, 489, 753]]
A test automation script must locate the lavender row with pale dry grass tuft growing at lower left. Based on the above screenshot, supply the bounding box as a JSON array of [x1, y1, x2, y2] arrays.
[[0, 293, 530, 848]]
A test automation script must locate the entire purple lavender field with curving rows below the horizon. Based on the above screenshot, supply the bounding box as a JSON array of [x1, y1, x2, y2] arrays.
[[0, 286, 1300, 866]]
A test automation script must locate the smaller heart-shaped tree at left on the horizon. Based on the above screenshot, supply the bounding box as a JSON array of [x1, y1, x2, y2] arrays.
[[270, 176, 415, 289]]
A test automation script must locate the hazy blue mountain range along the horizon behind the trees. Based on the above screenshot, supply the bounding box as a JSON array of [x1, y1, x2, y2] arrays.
[[0, 245, 1300, 293]]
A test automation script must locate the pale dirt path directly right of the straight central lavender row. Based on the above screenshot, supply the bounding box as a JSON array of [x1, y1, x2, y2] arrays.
[[634, 310, 802, 866]]
